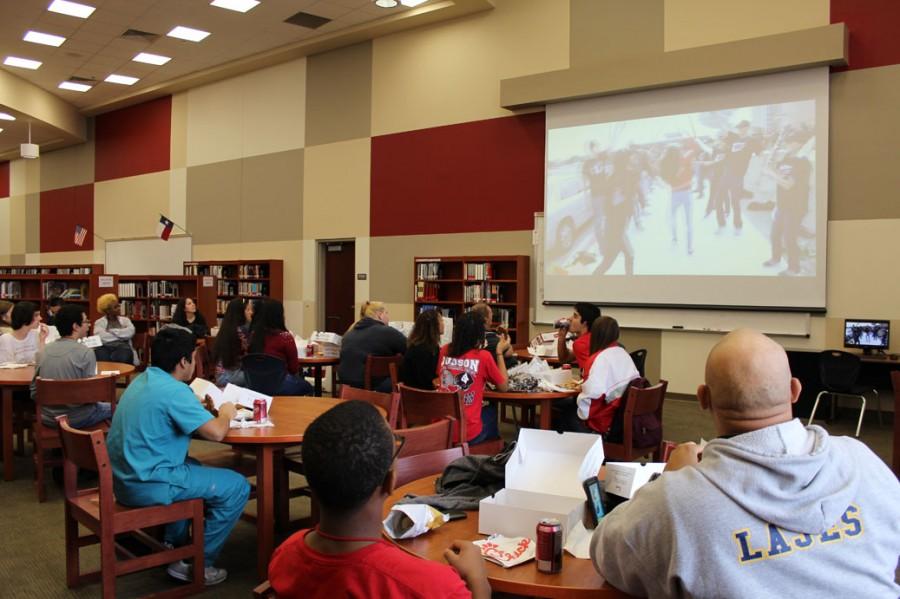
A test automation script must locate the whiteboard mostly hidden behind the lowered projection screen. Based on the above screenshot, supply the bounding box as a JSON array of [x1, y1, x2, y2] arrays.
[[532, 212, 811, 337]]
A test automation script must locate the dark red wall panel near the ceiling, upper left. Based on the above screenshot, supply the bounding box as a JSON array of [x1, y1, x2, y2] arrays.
[[94, 96, 172, 181]]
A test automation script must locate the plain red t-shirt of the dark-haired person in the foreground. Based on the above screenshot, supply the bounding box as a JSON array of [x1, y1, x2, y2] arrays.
[[269, 530, 472, 599]]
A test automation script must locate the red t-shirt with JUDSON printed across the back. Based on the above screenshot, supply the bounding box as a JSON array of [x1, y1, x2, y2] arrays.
[[437, 345, 502, 441]]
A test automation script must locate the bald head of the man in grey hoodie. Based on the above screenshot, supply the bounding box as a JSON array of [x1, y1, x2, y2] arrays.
[[699, 329, 800, 432]]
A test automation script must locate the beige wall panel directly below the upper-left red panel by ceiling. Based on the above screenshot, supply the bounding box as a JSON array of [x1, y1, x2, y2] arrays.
[[94, 171, 171, 239]]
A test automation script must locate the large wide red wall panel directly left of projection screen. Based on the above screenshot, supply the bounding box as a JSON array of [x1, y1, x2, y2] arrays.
[[370, 112, 544, 236]]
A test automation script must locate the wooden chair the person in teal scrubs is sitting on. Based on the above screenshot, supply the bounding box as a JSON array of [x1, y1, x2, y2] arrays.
[[57, 416, 204, 599]]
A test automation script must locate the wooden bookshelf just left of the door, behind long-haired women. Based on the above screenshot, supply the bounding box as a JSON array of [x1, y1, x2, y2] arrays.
[[184, 260, 284, 326]]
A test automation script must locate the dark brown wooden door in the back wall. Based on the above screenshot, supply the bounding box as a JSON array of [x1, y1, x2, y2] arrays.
[[322, 241, 356, 335]]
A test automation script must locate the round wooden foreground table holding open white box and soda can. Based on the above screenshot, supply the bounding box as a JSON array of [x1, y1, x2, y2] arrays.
[[384, 476, 631, 599]]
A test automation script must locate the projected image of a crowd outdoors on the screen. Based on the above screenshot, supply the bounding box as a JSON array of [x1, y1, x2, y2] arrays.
[[544, 100, 816, 277]]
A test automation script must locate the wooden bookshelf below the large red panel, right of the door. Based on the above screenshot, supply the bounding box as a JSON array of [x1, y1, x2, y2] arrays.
[[413, 256, 530, 348]]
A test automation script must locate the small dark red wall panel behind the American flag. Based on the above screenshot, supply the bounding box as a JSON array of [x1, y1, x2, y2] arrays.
[[41, 183, 94, 252]]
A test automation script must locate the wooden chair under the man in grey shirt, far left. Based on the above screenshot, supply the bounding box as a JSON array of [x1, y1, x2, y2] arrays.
[[31, 376, 116, 503]]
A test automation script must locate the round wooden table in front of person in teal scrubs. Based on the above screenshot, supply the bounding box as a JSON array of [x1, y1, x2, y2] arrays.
[[222, 396, 341, 580]]
